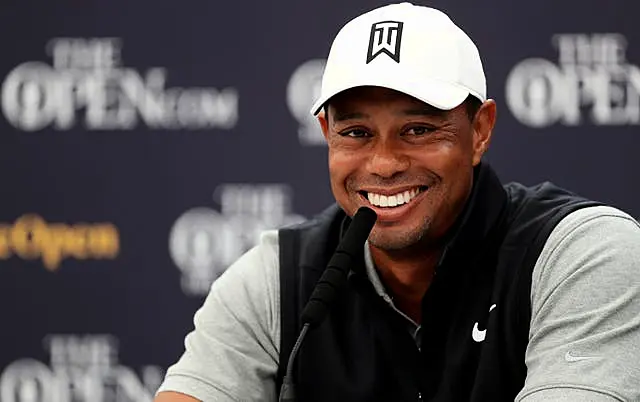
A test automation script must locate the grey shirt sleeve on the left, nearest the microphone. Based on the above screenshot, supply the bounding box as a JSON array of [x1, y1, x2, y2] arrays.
[[157, 231, 280, 402]]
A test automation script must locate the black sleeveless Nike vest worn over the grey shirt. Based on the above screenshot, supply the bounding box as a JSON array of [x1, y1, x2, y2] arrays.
[[277, 164, 596, 402]]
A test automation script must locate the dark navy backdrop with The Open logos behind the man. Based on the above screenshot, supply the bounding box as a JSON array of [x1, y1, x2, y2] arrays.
[[0, 0, 640, 402]]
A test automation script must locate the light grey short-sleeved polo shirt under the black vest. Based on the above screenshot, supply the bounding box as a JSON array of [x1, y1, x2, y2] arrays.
[[158, 206, 640, 402]]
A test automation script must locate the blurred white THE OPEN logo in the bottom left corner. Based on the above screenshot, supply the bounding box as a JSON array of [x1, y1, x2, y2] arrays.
[[0, 335, 164, 402]]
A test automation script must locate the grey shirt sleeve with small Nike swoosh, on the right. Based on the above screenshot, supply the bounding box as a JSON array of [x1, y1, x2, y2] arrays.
[[516, 206, 640, 402]]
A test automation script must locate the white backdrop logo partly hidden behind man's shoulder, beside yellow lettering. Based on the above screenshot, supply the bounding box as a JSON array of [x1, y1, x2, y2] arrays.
[[169, 184, 304, 296]]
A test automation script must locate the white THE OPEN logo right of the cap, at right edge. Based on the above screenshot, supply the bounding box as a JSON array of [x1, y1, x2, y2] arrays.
[[506, 33, 640, 127]]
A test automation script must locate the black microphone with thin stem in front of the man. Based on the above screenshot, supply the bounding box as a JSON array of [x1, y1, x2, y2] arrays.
[[279, 207, 377, 402]]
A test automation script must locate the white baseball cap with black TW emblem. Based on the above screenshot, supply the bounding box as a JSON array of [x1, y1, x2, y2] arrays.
[[311, 3, 487, 115]]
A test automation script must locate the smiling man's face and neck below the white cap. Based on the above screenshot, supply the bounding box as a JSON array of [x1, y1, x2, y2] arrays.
[[320, 85, 496, 322]]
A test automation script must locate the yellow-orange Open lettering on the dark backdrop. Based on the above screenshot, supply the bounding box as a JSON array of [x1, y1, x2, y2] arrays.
[[0, 214, 120, 271]]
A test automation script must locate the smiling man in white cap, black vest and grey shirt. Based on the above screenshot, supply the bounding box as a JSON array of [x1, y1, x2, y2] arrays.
[[156, 3, 640, 402]]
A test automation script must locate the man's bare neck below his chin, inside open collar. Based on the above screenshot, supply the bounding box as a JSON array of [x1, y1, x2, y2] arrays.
[[369, 245, 442, 323]]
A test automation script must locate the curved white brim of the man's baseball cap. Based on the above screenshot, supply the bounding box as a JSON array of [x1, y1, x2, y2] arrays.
[[311, 75, 471, 116]]
